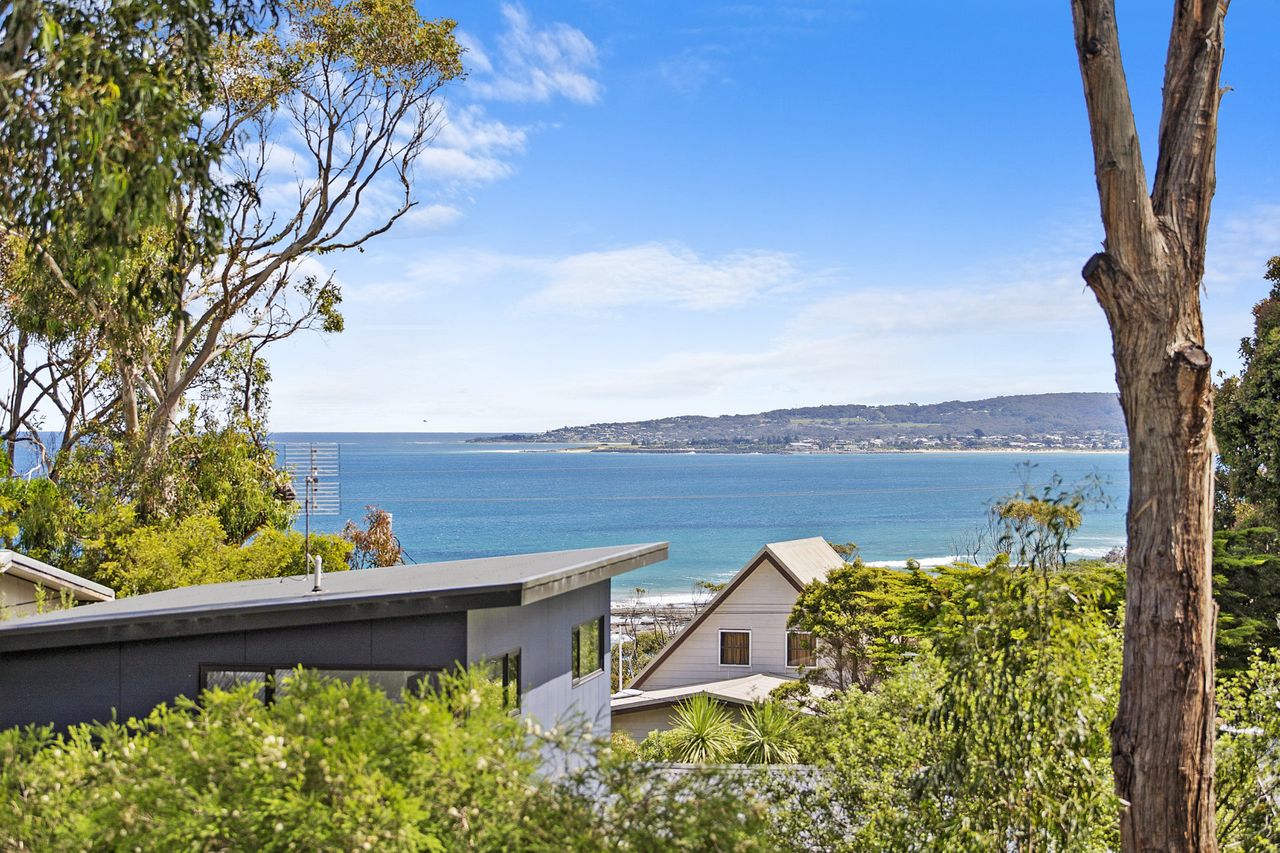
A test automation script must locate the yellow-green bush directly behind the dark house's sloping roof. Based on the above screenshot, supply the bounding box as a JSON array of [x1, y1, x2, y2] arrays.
[[96, 515, 351, 596]]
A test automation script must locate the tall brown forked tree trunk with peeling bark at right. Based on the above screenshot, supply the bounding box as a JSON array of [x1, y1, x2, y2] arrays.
[[1071, 0, 1228, 852]]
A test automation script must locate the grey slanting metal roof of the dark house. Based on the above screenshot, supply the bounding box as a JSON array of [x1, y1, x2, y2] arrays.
[[0, 542, 667, 653]]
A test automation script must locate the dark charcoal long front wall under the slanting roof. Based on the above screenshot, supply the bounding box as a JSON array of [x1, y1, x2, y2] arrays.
[[0, 613, 466, 727]]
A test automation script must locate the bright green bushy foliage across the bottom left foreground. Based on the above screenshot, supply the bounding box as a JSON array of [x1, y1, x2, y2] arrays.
[[0, 671, 788, 853]]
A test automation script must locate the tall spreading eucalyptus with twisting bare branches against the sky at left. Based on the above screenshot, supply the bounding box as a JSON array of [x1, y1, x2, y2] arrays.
[[0, 0, 462, 476]]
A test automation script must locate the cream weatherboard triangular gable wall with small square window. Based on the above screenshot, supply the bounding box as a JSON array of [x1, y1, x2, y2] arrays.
[[640, 557, 799, 690]]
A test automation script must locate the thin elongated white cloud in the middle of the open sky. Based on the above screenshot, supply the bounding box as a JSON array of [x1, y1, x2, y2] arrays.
[[532, 243, 800, 310]]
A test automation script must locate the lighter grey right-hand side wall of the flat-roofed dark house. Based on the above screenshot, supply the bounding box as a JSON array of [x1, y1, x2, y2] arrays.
[[467, 580, 611, 735]]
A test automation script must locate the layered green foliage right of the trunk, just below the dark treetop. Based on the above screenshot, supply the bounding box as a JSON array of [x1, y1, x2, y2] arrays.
[[1213, 528, 1280, 676]]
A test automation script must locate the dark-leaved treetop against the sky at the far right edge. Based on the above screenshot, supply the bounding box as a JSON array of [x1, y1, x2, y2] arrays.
[[1213, 256, 1280, 529]]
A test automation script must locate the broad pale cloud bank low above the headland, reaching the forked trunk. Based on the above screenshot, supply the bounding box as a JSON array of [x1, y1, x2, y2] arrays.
[[544, 270, 1111, 415]]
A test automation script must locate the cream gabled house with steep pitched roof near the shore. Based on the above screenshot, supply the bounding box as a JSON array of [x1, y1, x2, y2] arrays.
[[611, 537, 845, 738]]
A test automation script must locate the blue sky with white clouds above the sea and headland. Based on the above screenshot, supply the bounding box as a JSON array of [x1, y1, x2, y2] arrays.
[[268, 0, 1280, 432]]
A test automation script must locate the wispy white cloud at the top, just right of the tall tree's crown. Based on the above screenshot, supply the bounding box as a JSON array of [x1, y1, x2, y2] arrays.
[[465, 4, 603, 104]]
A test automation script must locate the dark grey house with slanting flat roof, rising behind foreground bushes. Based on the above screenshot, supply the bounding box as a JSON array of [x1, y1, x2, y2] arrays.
[[0, 543, 667, 734]]
